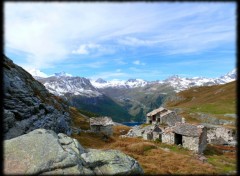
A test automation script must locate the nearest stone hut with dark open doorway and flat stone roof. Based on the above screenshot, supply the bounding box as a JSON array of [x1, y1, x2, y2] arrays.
[[162, 122, 207, 154]]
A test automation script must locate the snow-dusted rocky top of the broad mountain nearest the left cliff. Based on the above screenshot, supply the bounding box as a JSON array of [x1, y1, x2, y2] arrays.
[[38, 75, 102, 97]]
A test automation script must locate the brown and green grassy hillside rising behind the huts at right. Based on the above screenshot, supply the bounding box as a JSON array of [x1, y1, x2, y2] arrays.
[[166, 81, 236, 126]]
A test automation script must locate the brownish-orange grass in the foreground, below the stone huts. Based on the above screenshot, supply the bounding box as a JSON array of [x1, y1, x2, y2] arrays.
[[70, 108, 236, 174]]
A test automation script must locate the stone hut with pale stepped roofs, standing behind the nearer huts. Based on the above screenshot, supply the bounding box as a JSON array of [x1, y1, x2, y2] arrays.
[[146, 107, 182, 126]]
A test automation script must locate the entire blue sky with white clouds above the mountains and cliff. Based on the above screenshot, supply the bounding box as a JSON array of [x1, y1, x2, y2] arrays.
[[4, 2, 237, 81]]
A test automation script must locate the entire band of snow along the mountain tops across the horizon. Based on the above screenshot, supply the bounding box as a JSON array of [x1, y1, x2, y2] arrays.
[[29, 69, 237, 97]]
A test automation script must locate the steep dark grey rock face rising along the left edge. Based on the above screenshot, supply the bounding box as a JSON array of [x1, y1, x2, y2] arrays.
[[3, 56, 71, 139]]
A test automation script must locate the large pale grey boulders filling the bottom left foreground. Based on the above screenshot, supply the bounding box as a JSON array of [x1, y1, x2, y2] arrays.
[[4, 129, 143, 175]]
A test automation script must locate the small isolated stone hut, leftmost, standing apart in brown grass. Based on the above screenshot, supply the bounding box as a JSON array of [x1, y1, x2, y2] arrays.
[[90, 117, 114, 136]]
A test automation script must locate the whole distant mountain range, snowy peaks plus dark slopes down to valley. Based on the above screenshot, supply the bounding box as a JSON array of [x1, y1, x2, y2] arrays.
[[35, 70, 236, 122]]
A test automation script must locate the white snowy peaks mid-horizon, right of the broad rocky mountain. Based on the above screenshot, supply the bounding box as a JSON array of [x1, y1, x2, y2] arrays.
[[90, 78, 148, 89]]
